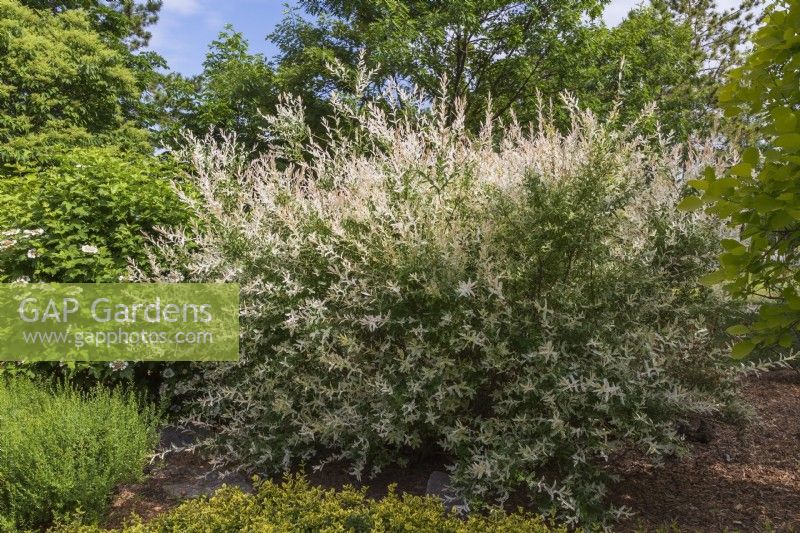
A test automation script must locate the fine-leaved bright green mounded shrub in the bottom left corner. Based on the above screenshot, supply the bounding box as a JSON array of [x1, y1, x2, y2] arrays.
[[0, 378, 156, 529]]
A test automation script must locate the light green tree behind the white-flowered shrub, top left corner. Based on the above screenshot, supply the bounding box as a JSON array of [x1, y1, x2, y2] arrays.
[[0, 0, 155, 163]]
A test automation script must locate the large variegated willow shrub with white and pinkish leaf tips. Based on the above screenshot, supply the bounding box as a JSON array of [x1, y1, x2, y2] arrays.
[[139, 83, 735, 523]]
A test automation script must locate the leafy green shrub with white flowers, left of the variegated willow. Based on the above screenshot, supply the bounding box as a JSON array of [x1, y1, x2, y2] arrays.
[[0, 147, 187, 283]]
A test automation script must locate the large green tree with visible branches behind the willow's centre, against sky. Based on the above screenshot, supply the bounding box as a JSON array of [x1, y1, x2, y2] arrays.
[[272, 0, 604, 127]]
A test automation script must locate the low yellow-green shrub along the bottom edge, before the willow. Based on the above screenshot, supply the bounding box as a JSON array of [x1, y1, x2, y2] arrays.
[[56, 478, 566, 533]]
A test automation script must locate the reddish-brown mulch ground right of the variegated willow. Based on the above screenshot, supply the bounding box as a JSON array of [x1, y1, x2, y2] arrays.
[[612, 370, 800, 531]]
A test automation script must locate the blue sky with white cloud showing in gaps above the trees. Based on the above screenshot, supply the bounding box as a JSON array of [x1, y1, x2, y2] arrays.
[[150, 0, 736, 75]]
